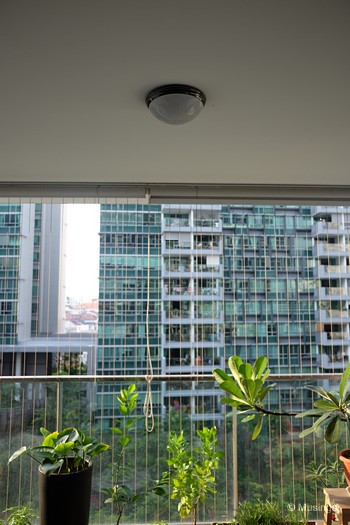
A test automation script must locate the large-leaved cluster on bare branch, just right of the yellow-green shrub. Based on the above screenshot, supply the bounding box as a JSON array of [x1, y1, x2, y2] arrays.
[[213, 356, 294, 440]]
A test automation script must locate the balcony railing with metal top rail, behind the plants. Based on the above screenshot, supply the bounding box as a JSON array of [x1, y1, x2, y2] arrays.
[[0, 369, 345, 525]]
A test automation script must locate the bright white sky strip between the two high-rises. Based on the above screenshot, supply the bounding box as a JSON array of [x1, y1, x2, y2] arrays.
[[66, 204, 100, 302]]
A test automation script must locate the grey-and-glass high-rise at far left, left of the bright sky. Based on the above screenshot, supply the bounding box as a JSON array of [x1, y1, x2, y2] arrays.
[[0, 204, 65, 375]]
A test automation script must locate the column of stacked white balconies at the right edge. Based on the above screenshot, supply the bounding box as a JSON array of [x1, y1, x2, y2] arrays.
[[312, 206, 350, 371]]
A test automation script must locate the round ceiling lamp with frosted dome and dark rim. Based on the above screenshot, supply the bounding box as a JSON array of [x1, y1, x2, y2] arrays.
[[146, 84, 206, 124]]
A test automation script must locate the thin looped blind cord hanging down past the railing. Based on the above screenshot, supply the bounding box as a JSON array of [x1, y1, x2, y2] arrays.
[[143, 204, 154, 432]]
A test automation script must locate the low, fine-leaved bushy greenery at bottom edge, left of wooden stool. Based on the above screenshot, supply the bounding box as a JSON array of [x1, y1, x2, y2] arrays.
[[234, 500, 307, 525]]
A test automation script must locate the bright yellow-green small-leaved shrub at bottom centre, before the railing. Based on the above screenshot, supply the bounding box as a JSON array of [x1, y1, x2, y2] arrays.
[[167, 427, 223, 525]]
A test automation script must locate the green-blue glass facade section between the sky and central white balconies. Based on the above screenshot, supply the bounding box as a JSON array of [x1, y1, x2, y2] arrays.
[[96, 205, 162, 427]]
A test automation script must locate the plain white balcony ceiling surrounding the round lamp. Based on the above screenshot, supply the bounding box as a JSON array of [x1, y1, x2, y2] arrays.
[[0, 0, 350, 192]]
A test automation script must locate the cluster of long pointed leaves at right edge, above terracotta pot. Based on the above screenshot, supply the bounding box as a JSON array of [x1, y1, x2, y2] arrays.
[[296, 363, 350, 443]]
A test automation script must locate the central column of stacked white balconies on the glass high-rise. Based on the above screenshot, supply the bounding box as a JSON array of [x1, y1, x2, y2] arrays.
[[161, 205, 225, 421]]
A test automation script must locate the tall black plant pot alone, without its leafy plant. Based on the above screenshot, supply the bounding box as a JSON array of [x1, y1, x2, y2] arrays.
[[39, 464, 92, 525]]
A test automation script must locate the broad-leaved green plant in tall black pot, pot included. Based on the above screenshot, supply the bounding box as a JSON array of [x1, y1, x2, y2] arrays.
[[9, 427, 109, 525]]
